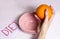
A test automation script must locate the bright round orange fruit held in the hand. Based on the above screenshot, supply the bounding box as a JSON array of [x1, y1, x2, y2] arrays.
[[36, 4, 53, 20]]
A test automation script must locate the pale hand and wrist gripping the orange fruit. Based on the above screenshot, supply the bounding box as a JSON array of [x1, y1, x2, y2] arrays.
[[37, 10, 54, 39]]
